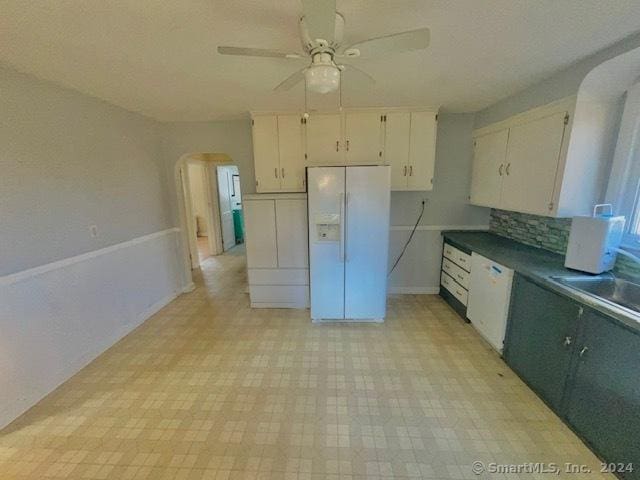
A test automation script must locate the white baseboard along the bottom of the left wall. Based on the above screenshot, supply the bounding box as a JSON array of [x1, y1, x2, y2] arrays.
[[0, 293, 178, 429]]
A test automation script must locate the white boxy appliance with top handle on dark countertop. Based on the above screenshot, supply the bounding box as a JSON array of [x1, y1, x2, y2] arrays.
[[564, 204, 625, 274]]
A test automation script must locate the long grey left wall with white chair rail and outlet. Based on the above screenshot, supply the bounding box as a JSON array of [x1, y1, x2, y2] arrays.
[[0, 68, 180, 427]]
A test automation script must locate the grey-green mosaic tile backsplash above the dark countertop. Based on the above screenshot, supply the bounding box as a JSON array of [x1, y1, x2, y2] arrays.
[[489, 209, 640, 277]]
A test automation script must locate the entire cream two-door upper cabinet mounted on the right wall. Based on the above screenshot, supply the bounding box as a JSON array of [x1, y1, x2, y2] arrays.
[[469, 97, 619, 217]]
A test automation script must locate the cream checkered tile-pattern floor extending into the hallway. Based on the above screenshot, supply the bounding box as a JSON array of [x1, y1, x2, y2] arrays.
[[0, 246, 609, 480]]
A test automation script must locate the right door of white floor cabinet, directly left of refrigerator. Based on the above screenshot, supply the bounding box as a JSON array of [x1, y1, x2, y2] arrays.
[[276, 199, 309, 268]]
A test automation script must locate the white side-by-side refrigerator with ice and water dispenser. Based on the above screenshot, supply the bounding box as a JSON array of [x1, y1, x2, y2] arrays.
[[307, 166, 391, 321]]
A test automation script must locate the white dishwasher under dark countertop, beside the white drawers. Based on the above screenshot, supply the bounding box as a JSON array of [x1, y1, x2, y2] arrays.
[[467, 252, 513, 352]]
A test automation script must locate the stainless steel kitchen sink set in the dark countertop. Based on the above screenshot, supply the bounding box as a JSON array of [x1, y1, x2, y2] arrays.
[[552, 275, 640, 315]]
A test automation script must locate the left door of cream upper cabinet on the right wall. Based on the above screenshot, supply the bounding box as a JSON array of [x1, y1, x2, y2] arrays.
[[470, 129, 509, 208]]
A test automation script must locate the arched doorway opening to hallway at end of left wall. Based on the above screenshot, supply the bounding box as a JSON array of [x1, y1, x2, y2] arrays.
[[176, 153, 244, 285]]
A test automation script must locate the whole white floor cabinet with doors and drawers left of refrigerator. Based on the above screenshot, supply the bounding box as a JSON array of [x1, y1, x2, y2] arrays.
[[243, 194, 309, 308]]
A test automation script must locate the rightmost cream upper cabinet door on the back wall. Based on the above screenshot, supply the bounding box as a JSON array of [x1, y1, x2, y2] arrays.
[[408, 112, 437, 190]]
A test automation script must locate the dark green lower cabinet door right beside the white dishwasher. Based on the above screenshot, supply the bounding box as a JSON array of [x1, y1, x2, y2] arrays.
[[504, 275, 580, 411]]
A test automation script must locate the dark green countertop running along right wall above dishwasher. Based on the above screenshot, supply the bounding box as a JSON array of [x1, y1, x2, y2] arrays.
[[442, 230, 640, 332]]
